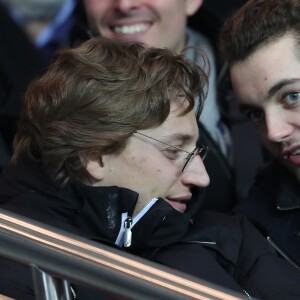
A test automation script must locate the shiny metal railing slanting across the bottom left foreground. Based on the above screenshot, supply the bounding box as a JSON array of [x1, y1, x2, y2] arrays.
[[0, 209, 246, 300]]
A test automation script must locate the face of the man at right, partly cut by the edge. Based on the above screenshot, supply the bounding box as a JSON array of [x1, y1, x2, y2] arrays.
[[231, 34, 300, 181]]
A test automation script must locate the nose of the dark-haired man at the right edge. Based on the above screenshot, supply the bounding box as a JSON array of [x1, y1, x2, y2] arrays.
[[265, 111, 293, 142]]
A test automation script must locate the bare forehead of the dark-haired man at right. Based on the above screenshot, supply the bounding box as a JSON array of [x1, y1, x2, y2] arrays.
[[230, 35, 300, 102]]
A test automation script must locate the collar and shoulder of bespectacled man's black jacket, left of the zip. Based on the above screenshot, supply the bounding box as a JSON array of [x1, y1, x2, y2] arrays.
[[0, 156, 138, 243]]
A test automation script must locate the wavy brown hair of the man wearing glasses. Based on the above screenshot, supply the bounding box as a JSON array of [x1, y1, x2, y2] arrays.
[[12, 37, 208, 185]]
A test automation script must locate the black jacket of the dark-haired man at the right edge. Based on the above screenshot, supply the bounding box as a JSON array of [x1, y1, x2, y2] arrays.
[[235, 161, 300, 270]]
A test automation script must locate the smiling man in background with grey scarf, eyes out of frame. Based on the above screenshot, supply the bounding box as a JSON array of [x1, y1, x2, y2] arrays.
[[83, 0, 235, 211]]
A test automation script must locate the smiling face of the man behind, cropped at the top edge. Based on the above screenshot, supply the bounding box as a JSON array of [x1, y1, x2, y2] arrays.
[[84, 0, 203, 52]]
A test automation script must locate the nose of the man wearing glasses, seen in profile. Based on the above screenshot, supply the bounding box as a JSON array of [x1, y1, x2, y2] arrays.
[[182, 155, 210, 187]]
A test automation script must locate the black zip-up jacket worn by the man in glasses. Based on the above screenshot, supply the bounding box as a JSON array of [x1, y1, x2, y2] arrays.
[[0, 159, 300, 300]]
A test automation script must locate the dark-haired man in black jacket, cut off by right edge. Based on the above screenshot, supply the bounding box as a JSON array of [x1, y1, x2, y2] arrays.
[[220, 0, 300, 268]]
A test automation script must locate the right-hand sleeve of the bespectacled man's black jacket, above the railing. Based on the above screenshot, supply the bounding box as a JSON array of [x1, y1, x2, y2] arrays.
[[146, 213, 300, 300]]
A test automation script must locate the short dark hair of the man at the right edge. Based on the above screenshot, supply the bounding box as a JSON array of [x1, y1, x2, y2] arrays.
[[219, 0, 300, 64]]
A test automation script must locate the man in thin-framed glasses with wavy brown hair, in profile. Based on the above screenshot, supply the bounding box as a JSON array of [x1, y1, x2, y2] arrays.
[[0, 38, 300, 300]]
